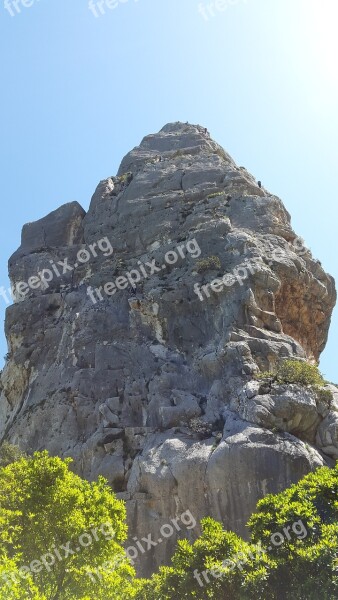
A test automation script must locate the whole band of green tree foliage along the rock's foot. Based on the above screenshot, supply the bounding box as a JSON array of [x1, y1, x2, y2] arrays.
[[0, 450, 338, 600]]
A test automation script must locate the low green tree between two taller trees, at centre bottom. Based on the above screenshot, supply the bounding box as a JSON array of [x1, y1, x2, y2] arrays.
[[137, 517, 270, 600]]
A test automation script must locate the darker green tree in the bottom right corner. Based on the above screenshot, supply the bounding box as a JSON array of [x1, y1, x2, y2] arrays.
[[249, 466, 338, 600]]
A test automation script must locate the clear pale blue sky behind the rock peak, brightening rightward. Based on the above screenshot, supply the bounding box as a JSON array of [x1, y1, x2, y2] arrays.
[[0, 0, 338, 381]]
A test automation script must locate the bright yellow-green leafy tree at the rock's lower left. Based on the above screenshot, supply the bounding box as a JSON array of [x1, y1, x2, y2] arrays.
[[0, 452, 135, 600]]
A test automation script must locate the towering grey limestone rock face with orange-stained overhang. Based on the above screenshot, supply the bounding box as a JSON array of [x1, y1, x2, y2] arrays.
[[0, 123, 338, 573]]
